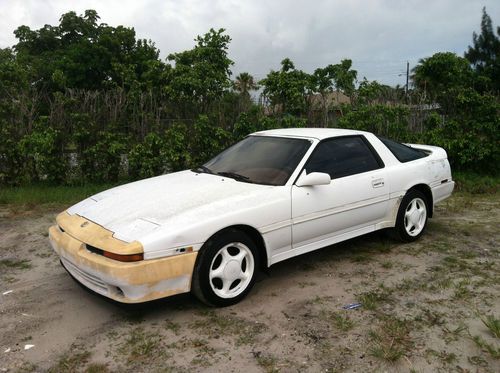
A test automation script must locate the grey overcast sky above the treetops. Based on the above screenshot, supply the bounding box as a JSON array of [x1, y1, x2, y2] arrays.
[[0, 0, 500, 85]]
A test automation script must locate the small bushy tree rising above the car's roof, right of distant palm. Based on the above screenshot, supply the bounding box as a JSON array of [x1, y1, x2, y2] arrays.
[[259, 58, 313, 114]]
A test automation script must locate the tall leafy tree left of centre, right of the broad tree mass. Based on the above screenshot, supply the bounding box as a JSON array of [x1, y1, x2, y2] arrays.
[[167, 29, 234, 112]]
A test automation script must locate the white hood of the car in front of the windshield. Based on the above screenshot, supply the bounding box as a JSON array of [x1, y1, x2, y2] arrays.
[[68, 171, 273, 242]]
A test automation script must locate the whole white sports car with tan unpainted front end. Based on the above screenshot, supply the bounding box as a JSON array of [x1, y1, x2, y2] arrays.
[[49, 128, 454, 306]]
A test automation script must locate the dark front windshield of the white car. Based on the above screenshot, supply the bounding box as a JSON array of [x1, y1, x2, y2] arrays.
[[194, 136, 311, 185]]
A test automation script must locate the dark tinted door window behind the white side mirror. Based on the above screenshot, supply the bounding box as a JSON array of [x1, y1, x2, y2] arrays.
[[305, 136, 383, 179]]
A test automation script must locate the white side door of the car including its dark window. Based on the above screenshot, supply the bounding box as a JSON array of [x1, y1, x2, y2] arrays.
[[292, 135, 389, 251]]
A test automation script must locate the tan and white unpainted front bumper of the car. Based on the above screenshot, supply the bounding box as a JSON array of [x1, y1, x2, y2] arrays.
[[49, 221, 197, 303]]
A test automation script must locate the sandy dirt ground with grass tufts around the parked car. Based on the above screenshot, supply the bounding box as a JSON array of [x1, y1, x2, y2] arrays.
[[0, 194, 500, 372]]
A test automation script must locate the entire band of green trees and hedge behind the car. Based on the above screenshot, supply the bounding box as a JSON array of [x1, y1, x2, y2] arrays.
[[0, 10, 500, 185]]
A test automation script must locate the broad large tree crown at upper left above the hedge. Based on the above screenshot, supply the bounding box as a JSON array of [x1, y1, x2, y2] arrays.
[[14, 10, 162, 92]]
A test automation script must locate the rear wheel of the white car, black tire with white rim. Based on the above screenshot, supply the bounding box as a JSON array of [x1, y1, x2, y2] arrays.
[[393, 189, 430, 242]]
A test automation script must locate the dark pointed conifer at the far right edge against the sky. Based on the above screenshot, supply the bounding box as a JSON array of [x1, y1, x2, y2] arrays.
[[465, 8, 500, 92]]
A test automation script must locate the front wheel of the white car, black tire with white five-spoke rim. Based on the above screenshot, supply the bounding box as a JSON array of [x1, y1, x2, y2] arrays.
[[191, 230, 260, 307]]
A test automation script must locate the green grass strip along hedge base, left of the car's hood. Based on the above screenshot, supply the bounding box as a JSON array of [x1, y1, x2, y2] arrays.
[[0, 184, 118, 205]]
